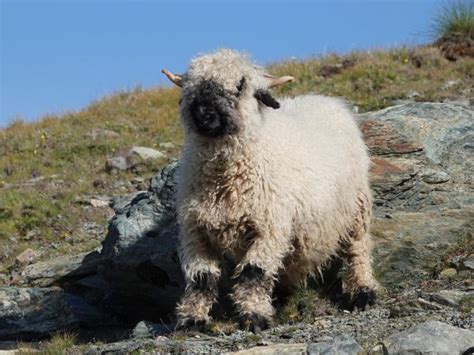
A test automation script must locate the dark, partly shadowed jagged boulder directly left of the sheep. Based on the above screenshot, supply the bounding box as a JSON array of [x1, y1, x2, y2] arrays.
[[100, 163, 184, 321]]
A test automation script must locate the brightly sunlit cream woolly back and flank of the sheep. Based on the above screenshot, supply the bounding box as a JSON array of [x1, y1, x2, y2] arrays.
[[263, 95, 369, 225]]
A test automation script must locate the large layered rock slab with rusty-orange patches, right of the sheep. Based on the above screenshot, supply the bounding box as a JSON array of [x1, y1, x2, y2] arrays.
[[359, 103, 474, 287]]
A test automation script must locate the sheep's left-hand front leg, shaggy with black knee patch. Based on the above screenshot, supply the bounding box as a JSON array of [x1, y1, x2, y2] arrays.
[[176, 231, 220, 330]]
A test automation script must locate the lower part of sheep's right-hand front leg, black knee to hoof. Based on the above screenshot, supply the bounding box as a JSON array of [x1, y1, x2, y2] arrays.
[[231, 264, 274, 332]]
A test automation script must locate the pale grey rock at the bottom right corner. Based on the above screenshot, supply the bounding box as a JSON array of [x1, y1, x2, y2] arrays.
[[384, 321, 474, 355]]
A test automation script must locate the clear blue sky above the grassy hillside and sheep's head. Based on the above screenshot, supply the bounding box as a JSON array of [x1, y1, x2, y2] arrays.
[[0, 0, 440, 126]]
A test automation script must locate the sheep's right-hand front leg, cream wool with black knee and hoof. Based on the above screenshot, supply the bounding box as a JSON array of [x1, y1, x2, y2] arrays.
[[231, 228, 290, 332]]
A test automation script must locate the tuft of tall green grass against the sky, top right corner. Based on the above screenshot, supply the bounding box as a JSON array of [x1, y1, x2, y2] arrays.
[[433, 0, 474, 39]]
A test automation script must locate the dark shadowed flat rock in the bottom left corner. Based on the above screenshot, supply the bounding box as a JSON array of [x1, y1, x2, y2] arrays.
[[0, 287, 79, 340]]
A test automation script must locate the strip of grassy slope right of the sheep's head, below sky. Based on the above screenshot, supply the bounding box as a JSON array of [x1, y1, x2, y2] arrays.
[[269, 47, 474, 112]]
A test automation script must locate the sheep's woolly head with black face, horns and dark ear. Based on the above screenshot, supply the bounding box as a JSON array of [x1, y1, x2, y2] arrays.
[[162, 49, 294, 137]]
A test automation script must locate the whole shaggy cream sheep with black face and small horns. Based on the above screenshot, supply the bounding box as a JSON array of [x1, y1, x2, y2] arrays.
[[162, 49, 377, 331]]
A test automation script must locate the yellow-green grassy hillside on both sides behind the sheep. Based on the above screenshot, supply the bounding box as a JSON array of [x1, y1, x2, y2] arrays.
[[0, 47, 474, 276]]
